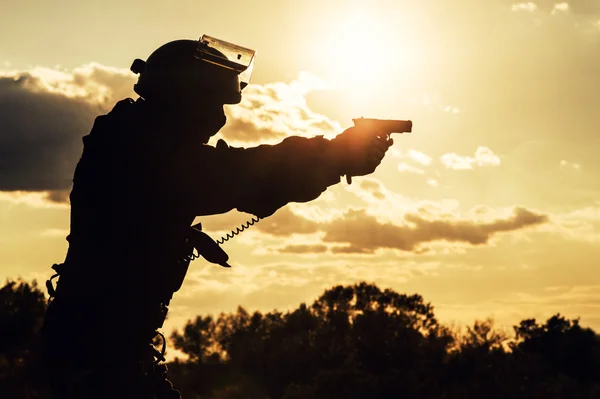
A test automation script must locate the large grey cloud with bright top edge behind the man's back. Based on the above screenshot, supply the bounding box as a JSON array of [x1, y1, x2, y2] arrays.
[[0, 64, 133, 194]]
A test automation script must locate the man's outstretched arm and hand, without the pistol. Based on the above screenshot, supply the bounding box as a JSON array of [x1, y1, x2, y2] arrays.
[[171, 128, 391, 217]]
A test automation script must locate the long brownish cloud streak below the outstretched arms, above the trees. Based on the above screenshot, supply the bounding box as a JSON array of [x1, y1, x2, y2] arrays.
[[256, 207, 549, 254]]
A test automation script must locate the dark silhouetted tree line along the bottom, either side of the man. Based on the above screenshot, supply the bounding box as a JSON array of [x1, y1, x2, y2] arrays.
[[0, 280, 600, 399]]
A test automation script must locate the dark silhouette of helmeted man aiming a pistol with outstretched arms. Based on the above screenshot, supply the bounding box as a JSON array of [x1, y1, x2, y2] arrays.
[[44, 36, 392, 399]]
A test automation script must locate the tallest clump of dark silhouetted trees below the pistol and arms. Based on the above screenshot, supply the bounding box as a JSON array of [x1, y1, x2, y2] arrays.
[[173, 283, 452, 398]]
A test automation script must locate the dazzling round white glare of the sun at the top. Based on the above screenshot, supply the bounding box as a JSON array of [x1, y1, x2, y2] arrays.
[[321, 4, 423, 111]]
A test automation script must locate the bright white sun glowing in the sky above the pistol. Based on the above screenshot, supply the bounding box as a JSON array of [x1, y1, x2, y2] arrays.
[[313, 2, 432, 114]]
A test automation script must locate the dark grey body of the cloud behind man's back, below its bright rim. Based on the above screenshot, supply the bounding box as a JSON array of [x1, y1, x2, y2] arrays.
[[0, 74, 99, 191]]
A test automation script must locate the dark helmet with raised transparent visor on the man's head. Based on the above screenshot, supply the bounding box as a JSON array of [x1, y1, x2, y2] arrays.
[[131, 35, 256, 104]]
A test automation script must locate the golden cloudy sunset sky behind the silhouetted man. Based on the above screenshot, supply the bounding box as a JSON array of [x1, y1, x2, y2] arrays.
[[0, 0, 600, 346]]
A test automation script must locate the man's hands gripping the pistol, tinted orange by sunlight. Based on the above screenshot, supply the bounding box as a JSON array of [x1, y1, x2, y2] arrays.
[[331, 127, 394, 177]]
